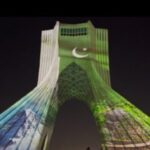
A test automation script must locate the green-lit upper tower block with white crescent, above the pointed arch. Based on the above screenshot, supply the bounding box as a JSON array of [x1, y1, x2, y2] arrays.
[[59, 21, 110, 85]]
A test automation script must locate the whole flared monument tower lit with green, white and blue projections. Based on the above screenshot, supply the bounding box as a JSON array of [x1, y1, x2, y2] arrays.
[[0, 21, 150, 150]]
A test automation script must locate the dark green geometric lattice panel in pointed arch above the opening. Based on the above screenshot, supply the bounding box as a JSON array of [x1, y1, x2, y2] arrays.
[[58, 63, 94, 103]]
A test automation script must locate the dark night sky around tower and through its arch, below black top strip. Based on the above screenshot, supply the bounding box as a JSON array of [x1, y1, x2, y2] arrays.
[[0, 17, 150, 150]]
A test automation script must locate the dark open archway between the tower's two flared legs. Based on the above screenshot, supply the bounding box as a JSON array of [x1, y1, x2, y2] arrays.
[[49, 99, 100, 150]]
